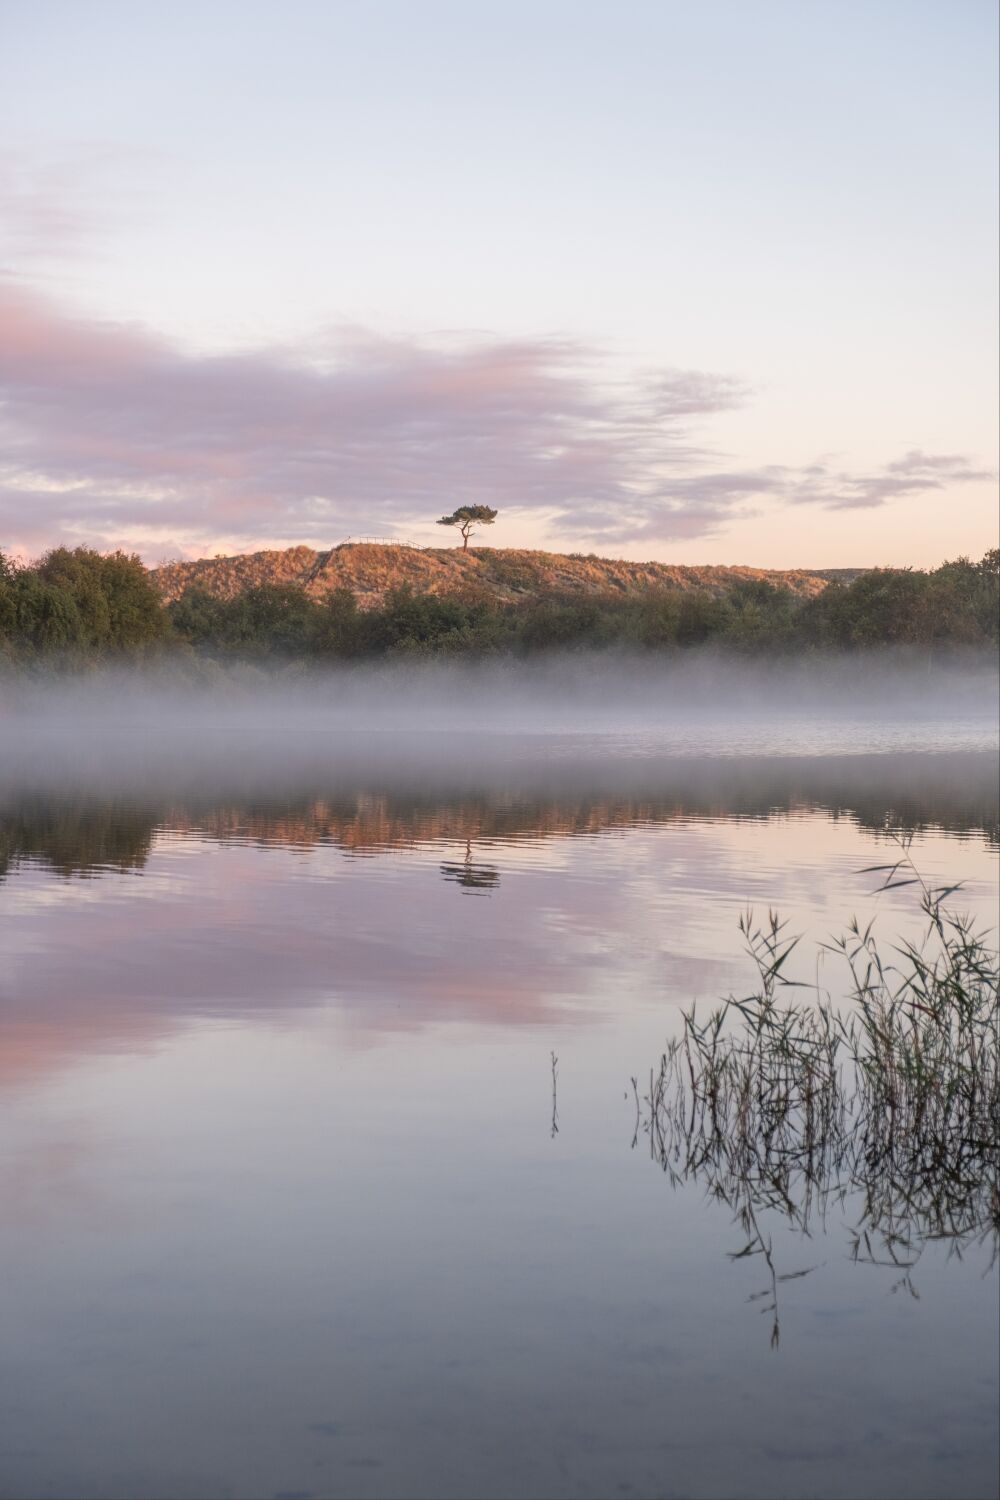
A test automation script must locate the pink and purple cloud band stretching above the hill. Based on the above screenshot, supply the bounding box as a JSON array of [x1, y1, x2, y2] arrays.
[[0, 282, 985, 555]]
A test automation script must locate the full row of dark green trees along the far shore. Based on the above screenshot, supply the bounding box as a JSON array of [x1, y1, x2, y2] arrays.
[[0, 548, 1000, 660]]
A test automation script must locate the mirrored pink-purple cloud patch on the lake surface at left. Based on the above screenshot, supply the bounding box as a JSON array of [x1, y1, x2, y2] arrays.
[[0, 839, 593, 1079]]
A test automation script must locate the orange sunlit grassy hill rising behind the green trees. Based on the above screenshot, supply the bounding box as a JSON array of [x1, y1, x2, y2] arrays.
[[151, 542, 862, 608]]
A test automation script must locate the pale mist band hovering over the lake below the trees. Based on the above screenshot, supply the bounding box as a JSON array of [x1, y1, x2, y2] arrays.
[[0, 653, 1000, 786]]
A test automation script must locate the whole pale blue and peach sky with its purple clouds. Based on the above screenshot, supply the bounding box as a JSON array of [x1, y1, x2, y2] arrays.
[[0, 0, 999, 567]]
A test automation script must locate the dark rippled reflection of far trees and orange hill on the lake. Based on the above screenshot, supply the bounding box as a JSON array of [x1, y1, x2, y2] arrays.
[[0, 756, 1000, 890]]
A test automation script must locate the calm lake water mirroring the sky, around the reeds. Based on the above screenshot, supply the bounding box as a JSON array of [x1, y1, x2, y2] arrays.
[[0, 705, 1000, 1500]]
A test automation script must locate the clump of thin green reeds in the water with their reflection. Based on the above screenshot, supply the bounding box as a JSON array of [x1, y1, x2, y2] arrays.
[[633, 843, 1000, 1344]]
